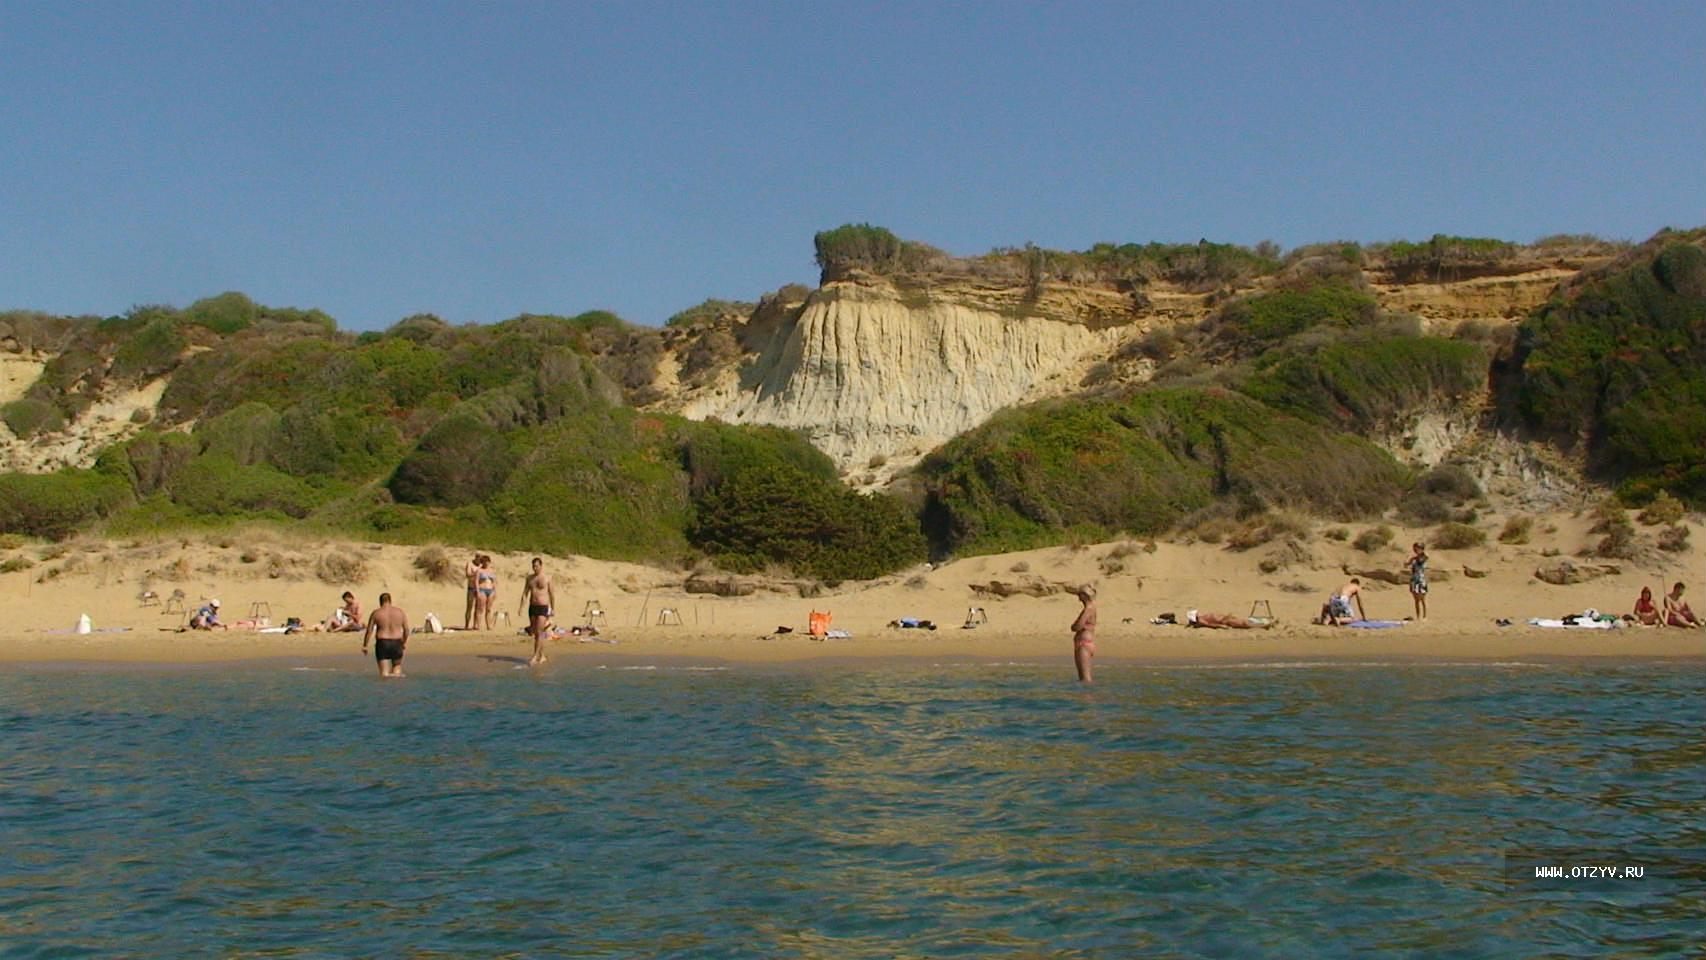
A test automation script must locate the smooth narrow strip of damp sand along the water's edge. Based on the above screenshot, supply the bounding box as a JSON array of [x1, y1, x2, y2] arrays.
[[0, 624, 1706, 675]]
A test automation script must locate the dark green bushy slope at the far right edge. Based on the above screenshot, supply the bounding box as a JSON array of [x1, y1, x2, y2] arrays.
[[1500, 244, 1706, 505]]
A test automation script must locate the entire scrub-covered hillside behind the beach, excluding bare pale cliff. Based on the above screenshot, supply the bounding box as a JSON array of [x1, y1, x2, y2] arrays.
[[0, 223, 1706, 581]]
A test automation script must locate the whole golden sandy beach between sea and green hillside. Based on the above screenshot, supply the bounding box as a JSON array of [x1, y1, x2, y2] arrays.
[[0, 517, 1706, 670]]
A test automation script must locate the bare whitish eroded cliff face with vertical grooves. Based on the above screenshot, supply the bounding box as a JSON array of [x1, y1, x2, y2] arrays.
[[682, 281, 1131, 483]]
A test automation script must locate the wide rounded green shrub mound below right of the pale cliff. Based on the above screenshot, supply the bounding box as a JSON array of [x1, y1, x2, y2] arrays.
[[918, 387, 1407, 552]]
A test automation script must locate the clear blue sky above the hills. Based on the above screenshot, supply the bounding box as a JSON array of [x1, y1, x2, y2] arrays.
[[0, 0, 1706, 329]]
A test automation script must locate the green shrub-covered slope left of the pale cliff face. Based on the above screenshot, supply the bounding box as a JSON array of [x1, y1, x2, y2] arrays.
[[0, 295, 925, 580]]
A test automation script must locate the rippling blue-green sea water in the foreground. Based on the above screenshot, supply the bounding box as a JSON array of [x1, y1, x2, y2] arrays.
[[0, 660, 1706, 958]]
